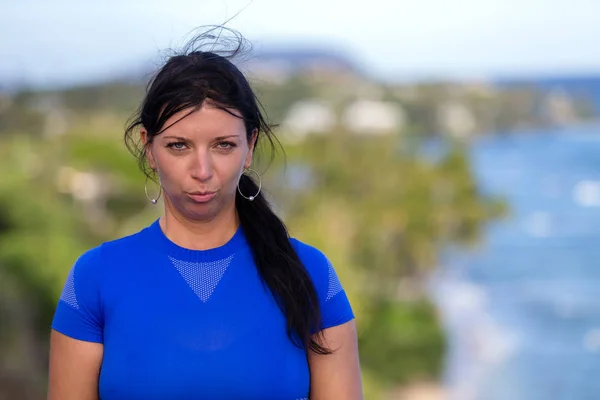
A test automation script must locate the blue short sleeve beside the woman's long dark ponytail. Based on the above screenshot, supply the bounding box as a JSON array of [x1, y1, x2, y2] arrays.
[[294, 239, 354, 329]]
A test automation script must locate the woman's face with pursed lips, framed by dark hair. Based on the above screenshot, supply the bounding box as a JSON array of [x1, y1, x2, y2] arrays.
[[141, 101, 256, 220]]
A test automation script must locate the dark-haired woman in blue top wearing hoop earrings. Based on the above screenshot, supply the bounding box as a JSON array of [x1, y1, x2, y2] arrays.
[[48, 28, 362, 400]]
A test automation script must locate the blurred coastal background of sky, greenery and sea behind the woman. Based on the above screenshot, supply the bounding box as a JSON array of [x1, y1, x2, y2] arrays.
[[0, 0, 600, 400]]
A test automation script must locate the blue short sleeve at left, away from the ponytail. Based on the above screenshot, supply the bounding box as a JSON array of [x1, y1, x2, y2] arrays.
[[52, 247, 104, 343]]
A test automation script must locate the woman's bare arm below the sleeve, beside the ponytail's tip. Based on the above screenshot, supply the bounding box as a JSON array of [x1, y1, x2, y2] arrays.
[[308, 320, 363, 400]]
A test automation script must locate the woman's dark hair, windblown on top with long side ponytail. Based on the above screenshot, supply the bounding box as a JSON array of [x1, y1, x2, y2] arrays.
[[125, 27, 331, 354]]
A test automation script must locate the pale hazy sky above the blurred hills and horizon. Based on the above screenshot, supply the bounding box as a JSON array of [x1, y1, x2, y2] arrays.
[[0, 0, 600, 85]]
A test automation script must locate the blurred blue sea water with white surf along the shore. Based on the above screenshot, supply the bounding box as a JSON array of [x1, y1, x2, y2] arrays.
[[433, 126, 600, 400]]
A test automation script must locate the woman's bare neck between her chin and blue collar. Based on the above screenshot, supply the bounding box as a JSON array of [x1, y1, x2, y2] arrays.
[[159, 205, 239, 250]]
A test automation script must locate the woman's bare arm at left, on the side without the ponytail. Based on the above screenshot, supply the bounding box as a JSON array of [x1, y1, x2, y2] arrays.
[[48, 330, 104, 400]]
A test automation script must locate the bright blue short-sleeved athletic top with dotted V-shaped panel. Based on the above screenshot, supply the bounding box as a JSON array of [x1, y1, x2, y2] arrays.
[[52, 220, 354, 400]]
